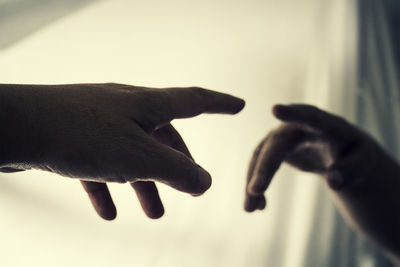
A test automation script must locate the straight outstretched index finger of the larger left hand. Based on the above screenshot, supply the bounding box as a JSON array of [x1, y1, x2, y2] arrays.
[[153, 87, 245, 122]]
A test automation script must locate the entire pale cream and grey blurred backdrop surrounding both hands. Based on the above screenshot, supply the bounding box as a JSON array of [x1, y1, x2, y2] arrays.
[[0, 0, 400, 267]]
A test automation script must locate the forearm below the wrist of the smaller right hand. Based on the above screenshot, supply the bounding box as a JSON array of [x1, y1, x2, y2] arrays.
[[335, 153, 400, 259]]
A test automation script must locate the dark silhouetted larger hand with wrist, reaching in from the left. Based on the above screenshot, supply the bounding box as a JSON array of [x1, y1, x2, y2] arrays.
[[0, 83, 244, 220]]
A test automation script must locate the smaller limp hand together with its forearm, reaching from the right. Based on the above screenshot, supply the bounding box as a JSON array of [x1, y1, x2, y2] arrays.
[[245, 105, 400, 261]]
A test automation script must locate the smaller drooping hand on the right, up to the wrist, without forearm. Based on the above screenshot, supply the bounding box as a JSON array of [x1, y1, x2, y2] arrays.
[[245, 105, 385, 212]]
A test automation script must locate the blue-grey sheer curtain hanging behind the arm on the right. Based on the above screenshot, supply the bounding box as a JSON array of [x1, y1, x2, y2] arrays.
[[296, 0, 400, 266]]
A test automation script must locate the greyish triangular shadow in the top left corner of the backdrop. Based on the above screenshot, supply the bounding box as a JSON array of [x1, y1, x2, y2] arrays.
[[0, 0, 96, 50]]
